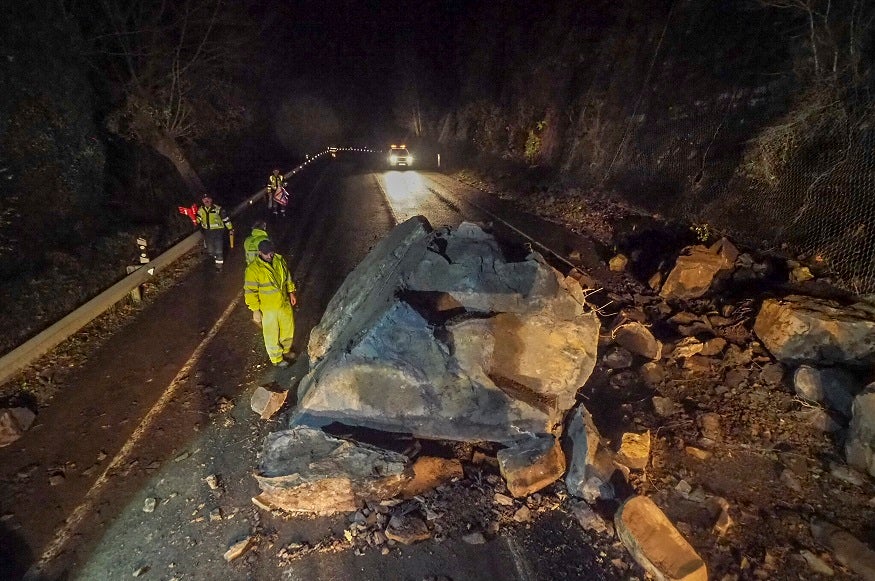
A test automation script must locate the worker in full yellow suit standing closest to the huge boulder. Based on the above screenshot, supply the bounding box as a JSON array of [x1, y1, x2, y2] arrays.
[[243, 240, 298, 367]]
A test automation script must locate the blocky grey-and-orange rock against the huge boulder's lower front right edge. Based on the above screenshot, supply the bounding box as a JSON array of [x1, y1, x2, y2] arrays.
[[497, 436, 565, 498]]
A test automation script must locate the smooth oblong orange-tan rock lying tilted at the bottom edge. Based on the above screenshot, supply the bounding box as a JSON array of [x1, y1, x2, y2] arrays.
[[614, 496, 708, 581]]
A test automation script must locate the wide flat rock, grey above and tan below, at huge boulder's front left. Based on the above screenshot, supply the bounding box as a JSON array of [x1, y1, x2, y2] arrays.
[[253, 427, 413, 515]]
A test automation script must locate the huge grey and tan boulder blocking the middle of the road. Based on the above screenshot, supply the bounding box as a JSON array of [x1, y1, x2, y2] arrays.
[[292, 220, 599, 442]]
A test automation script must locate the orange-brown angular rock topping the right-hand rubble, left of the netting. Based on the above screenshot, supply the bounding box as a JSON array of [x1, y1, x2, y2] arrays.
[[659, 238, 738, 300]]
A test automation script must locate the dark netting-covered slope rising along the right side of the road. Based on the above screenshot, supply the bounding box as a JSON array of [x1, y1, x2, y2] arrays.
[[448, 0, 875, 293]]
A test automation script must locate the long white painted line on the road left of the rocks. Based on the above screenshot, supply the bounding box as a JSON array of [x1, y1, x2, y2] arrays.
[[24, 290, 243, 580]]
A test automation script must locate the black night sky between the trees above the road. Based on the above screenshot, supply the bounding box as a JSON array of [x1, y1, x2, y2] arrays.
[[250, 0, 472, 147]]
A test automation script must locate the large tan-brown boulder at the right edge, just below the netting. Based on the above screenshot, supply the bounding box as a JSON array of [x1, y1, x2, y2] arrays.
[[753, 295, 875, 367]]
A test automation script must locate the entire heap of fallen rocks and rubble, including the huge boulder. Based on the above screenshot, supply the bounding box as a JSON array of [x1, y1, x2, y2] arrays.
[[246, 218, 875, 579]]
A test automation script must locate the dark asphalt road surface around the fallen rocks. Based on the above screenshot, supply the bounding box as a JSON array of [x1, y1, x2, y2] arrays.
[[0, 156, 628, 581]]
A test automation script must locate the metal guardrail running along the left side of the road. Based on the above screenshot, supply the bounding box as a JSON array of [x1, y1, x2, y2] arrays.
[[0, 148, 338, 385]]
